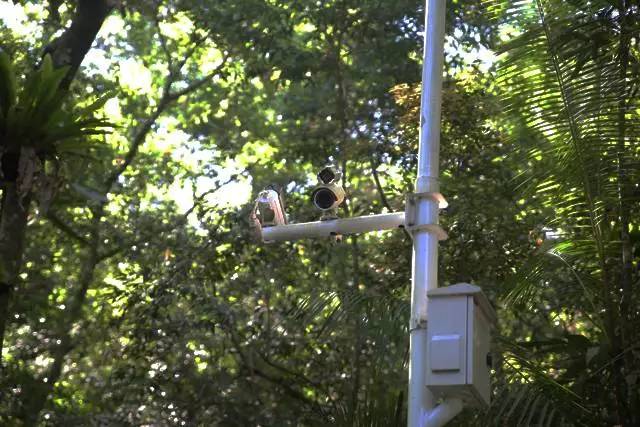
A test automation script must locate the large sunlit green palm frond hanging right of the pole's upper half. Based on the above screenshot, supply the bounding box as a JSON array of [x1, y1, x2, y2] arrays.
[[485, 0, 640, 310]]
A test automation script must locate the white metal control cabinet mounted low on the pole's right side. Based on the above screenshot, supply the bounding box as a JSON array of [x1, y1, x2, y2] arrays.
[[427, 283, 496, 406]]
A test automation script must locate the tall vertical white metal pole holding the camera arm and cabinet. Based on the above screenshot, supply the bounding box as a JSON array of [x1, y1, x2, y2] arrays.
[[408, 0, 446, 427]]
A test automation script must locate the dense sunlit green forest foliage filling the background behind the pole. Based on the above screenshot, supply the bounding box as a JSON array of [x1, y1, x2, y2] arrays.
[[0, 0, 640, 426]]
